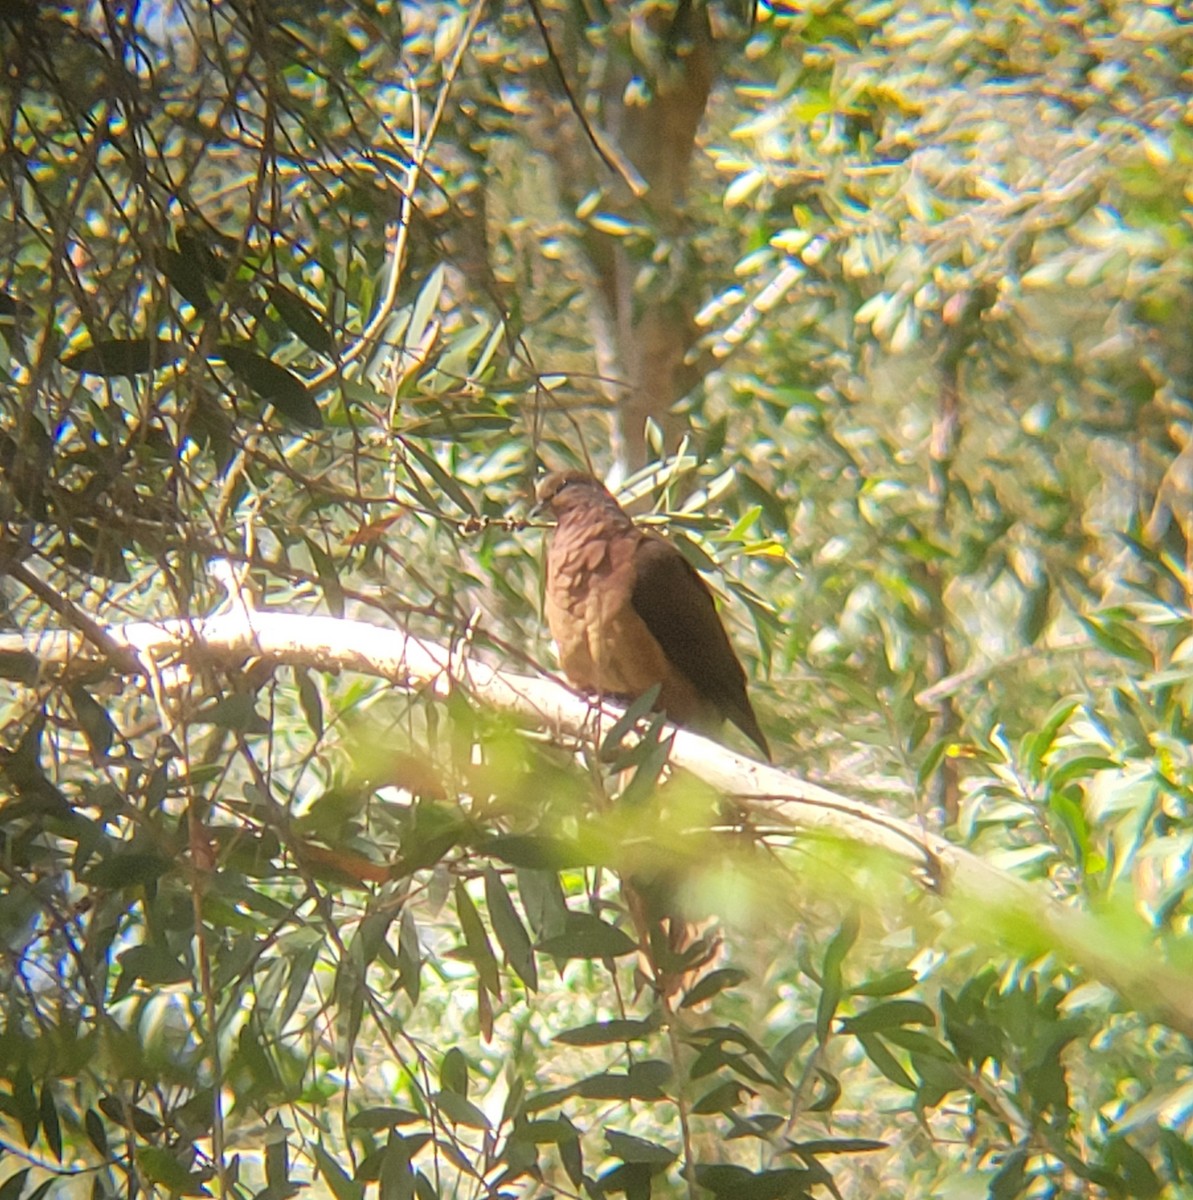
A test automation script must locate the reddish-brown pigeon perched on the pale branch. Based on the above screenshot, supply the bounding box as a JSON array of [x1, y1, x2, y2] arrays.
[[535, 470, 771, 760]]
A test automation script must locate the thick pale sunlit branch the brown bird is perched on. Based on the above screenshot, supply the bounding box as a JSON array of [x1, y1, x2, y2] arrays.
[[0, 610, 1193, 1037]]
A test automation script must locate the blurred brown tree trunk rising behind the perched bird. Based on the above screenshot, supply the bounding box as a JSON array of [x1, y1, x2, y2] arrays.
[[528, 0, 717, 470]]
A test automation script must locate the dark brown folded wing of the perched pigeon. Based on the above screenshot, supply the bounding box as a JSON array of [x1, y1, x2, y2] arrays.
[[630, 534, 771, 758]]
